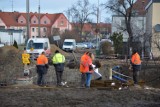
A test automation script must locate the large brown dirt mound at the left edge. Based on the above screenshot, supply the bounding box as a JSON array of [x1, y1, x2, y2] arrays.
[[0, 46, 23, 83]]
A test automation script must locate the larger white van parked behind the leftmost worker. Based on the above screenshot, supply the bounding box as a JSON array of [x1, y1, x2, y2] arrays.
[[26, 38, 51, 59]]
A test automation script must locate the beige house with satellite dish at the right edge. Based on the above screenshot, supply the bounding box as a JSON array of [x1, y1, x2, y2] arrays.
[[145, 0, 160, 57]]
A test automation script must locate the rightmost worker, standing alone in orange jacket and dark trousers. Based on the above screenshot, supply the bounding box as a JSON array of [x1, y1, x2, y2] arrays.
[[131, 50, 141, 85]]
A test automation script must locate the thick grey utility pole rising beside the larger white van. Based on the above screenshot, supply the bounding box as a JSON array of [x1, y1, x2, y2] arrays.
[[25, 0, 30, 43]]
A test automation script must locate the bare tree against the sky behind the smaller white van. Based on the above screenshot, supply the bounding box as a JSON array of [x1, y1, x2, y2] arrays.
[[68, 0, 93, 35]]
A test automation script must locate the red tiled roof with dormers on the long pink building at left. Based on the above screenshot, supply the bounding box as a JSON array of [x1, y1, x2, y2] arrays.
[[0, 12, 63, 27]]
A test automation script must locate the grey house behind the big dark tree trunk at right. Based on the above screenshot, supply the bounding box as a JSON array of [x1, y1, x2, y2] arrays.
[[112, 0, 148, 42]]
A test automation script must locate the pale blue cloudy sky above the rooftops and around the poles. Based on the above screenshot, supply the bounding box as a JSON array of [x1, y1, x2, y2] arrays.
[[0, 0, 108, 22]]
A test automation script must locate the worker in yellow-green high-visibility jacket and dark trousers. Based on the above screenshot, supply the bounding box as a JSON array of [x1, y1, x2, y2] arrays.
[[52, 50, 65, 86]]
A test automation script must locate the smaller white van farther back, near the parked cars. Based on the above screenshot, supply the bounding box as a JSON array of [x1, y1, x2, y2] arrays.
[[62, 39, 76, 51]]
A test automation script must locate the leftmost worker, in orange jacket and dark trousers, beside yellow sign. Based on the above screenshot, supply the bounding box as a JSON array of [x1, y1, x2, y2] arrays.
[[36, 52, 49, 86]]
